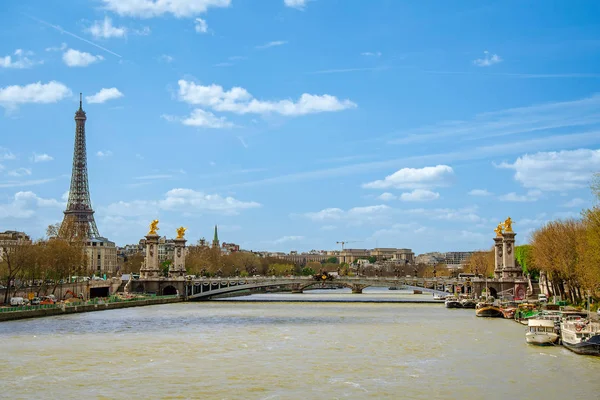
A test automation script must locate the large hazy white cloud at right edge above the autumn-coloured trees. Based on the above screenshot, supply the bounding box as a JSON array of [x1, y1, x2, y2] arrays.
[[499, 149, 600, 191]]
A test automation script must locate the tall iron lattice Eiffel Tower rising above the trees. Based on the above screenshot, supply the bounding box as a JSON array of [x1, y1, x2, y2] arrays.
[[61, 93, 100, 239]]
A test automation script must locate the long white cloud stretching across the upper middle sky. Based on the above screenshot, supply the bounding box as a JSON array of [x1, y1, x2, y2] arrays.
[[178, 79, 357, 116]]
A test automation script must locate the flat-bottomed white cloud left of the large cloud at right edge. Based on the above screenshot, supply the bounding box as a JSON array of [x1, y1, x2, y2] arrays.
[[362, 165, 454, 189]]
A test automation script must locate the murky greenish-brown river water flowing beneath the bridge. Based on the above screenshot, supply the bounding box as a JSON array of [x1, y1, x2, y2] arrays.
[[0, 291, 600, 400]]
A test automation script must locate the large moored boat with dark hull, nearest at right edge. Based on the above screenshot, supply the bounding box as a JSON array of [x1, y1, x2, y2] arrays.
[[560, 317, 600, 356]]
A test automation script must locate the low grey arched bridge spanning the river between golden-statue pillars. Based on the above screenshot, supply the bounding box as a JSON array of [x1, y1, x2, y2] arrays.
[[185, 276, 458, 300]]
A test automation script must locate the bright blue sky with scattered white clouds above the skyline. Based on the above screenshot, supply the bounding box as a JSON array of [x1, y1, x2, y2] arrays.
[[0, 0, 600, 253]]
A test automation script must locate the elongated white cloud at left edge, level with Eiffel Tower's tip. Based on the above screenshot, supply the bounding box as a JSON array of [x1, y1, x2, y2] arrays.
[[0, 81, 71, 108]]
